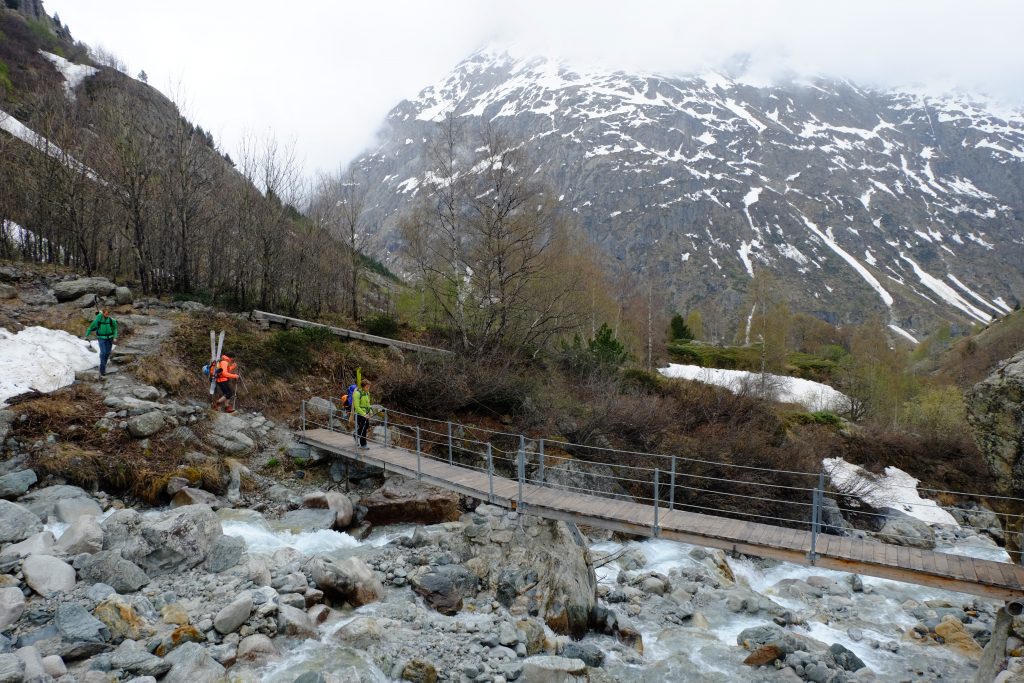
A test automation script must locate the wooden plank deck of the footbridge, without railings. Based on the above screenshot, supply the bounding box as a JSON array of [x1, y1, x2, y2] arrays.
[[300, 429, 1024, 600]]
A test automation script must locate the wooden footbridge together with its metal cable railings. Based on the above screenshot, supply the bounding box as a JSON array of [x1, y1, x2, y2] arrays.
[[300, 400, 1024, 600]]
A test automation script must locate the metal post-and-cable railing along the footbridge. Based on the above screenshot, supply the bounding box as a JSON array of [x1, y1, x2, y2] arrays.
[[300, 398, 1024, 564]]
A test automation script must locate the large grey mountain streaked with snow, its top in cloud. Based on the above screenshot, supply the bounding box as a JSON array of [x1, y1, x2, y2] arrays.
[[354, 49, 1024, 337]]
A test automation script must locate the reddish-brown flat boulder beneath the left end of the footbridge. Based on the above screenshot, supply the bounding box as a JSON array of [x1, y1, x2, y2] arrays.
[[359, 476, 461, 524]]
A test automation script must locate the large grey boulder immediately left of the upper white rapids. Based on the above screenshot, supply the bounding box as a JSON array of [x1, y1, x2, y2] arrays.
[[133, 505, 223, 577]]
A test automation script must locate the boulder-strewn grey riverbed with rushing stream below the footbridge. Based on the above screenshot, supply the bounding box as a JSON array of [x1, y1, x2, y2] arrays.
[[0, 270, 1024, 683]]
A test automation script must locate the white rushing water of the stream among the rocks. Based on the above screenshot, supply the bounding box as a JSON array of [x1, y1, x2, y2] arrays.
[[211, 510, 1007, 683]]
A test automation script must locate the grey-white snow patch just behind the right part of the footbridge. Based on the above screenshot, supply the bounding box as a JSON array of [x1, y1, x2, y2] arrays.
[[821, 458, 959, 526]]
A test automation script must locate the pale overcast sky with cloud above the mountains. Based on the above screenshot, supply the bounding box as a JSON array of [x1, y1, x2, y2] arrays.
[[44, 0, 1024, 180]]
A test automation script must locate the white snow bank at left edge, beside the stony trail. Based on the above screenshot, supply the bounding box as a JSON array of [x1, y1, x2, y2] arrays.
[[0, 328, 99, 407]]
